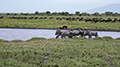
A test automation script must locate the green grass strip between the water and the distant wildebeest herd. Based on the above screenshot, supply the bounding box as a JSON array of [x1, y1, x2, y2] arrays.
[[0, 15, 120, 30]]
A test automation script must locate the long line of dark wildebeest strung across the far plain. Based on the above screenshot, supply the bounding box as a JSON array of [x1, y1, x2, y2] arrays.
[[0, 16, 120, 23]]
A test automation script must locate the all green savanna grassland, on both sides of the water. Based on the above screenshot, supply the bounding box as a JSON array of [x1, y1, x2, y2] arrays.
[[0, 15, 120, 67]]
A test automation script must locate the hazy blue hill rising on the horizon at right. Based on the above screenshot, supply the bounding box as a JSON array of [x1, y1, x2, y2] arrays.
[[84, 4, 120, 13]]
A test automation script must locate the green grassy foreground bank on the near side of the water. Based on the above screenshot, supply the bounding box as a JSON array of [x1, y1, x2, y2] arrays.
[[0, 37, 120, 67]]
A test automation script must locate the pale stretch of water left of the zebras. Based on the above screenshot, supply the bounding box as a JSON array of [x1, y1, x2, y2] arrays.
[[0, 28, 55, 41]]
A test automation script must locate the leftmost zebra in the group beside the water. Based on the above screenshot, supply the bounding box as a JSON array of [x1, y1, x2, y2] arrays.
[[55, 29, 73, 38]]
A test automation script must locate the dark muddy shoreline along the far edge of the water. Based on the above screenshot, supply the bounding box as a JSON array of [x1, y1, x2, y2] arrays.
[[0, 27, 120, 32]]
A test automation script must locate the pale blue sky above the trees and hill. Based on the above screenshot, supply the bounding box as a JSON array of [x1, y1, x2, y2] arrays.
[[0, 0, 120, 13]]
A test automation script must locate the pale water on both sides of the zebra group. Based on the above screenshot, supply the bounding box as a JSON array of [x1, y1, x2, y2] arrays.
[[0, 28, 120, 41]]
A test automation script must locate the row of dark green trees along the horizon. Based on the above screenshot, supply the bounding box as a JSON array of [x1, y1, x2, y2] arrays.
[[0, 11, 120, 16]]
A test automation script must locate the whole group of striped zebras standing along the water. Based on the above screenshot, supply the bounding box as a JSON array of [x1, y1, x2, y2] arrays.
[[55, 29, 98, 39]]
